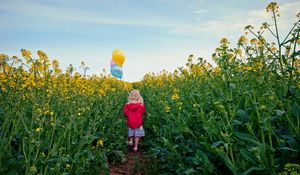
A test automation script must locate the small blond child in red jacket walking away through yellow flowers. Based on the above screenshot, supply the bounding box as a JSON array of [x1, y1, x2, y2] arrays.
[[124, 90, 146, 152]]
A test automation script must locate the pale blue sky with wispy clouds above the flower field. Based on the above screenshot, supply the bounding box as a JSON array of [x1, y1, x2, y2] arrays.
[[0, 0, 300, 82]]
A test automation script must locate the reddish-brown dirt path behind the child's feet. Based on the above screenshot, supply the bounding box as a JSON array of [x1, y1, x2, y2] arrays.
[[109, 150, 144, 175]]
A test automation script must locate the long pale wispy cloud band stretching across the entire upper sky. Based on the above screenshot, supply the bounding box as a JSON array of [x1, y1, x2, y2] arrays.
[[0, 0, 300, 36]]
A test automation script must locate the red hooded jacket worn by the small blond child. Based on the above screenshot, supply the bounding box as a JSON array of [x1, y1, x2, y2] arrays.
[[124, 103, 146, 128]]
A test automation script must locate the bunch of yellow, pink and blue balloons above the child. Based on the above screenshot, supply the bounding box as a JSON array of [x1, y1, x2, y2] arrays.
[[110, 49, 125, 79]]
